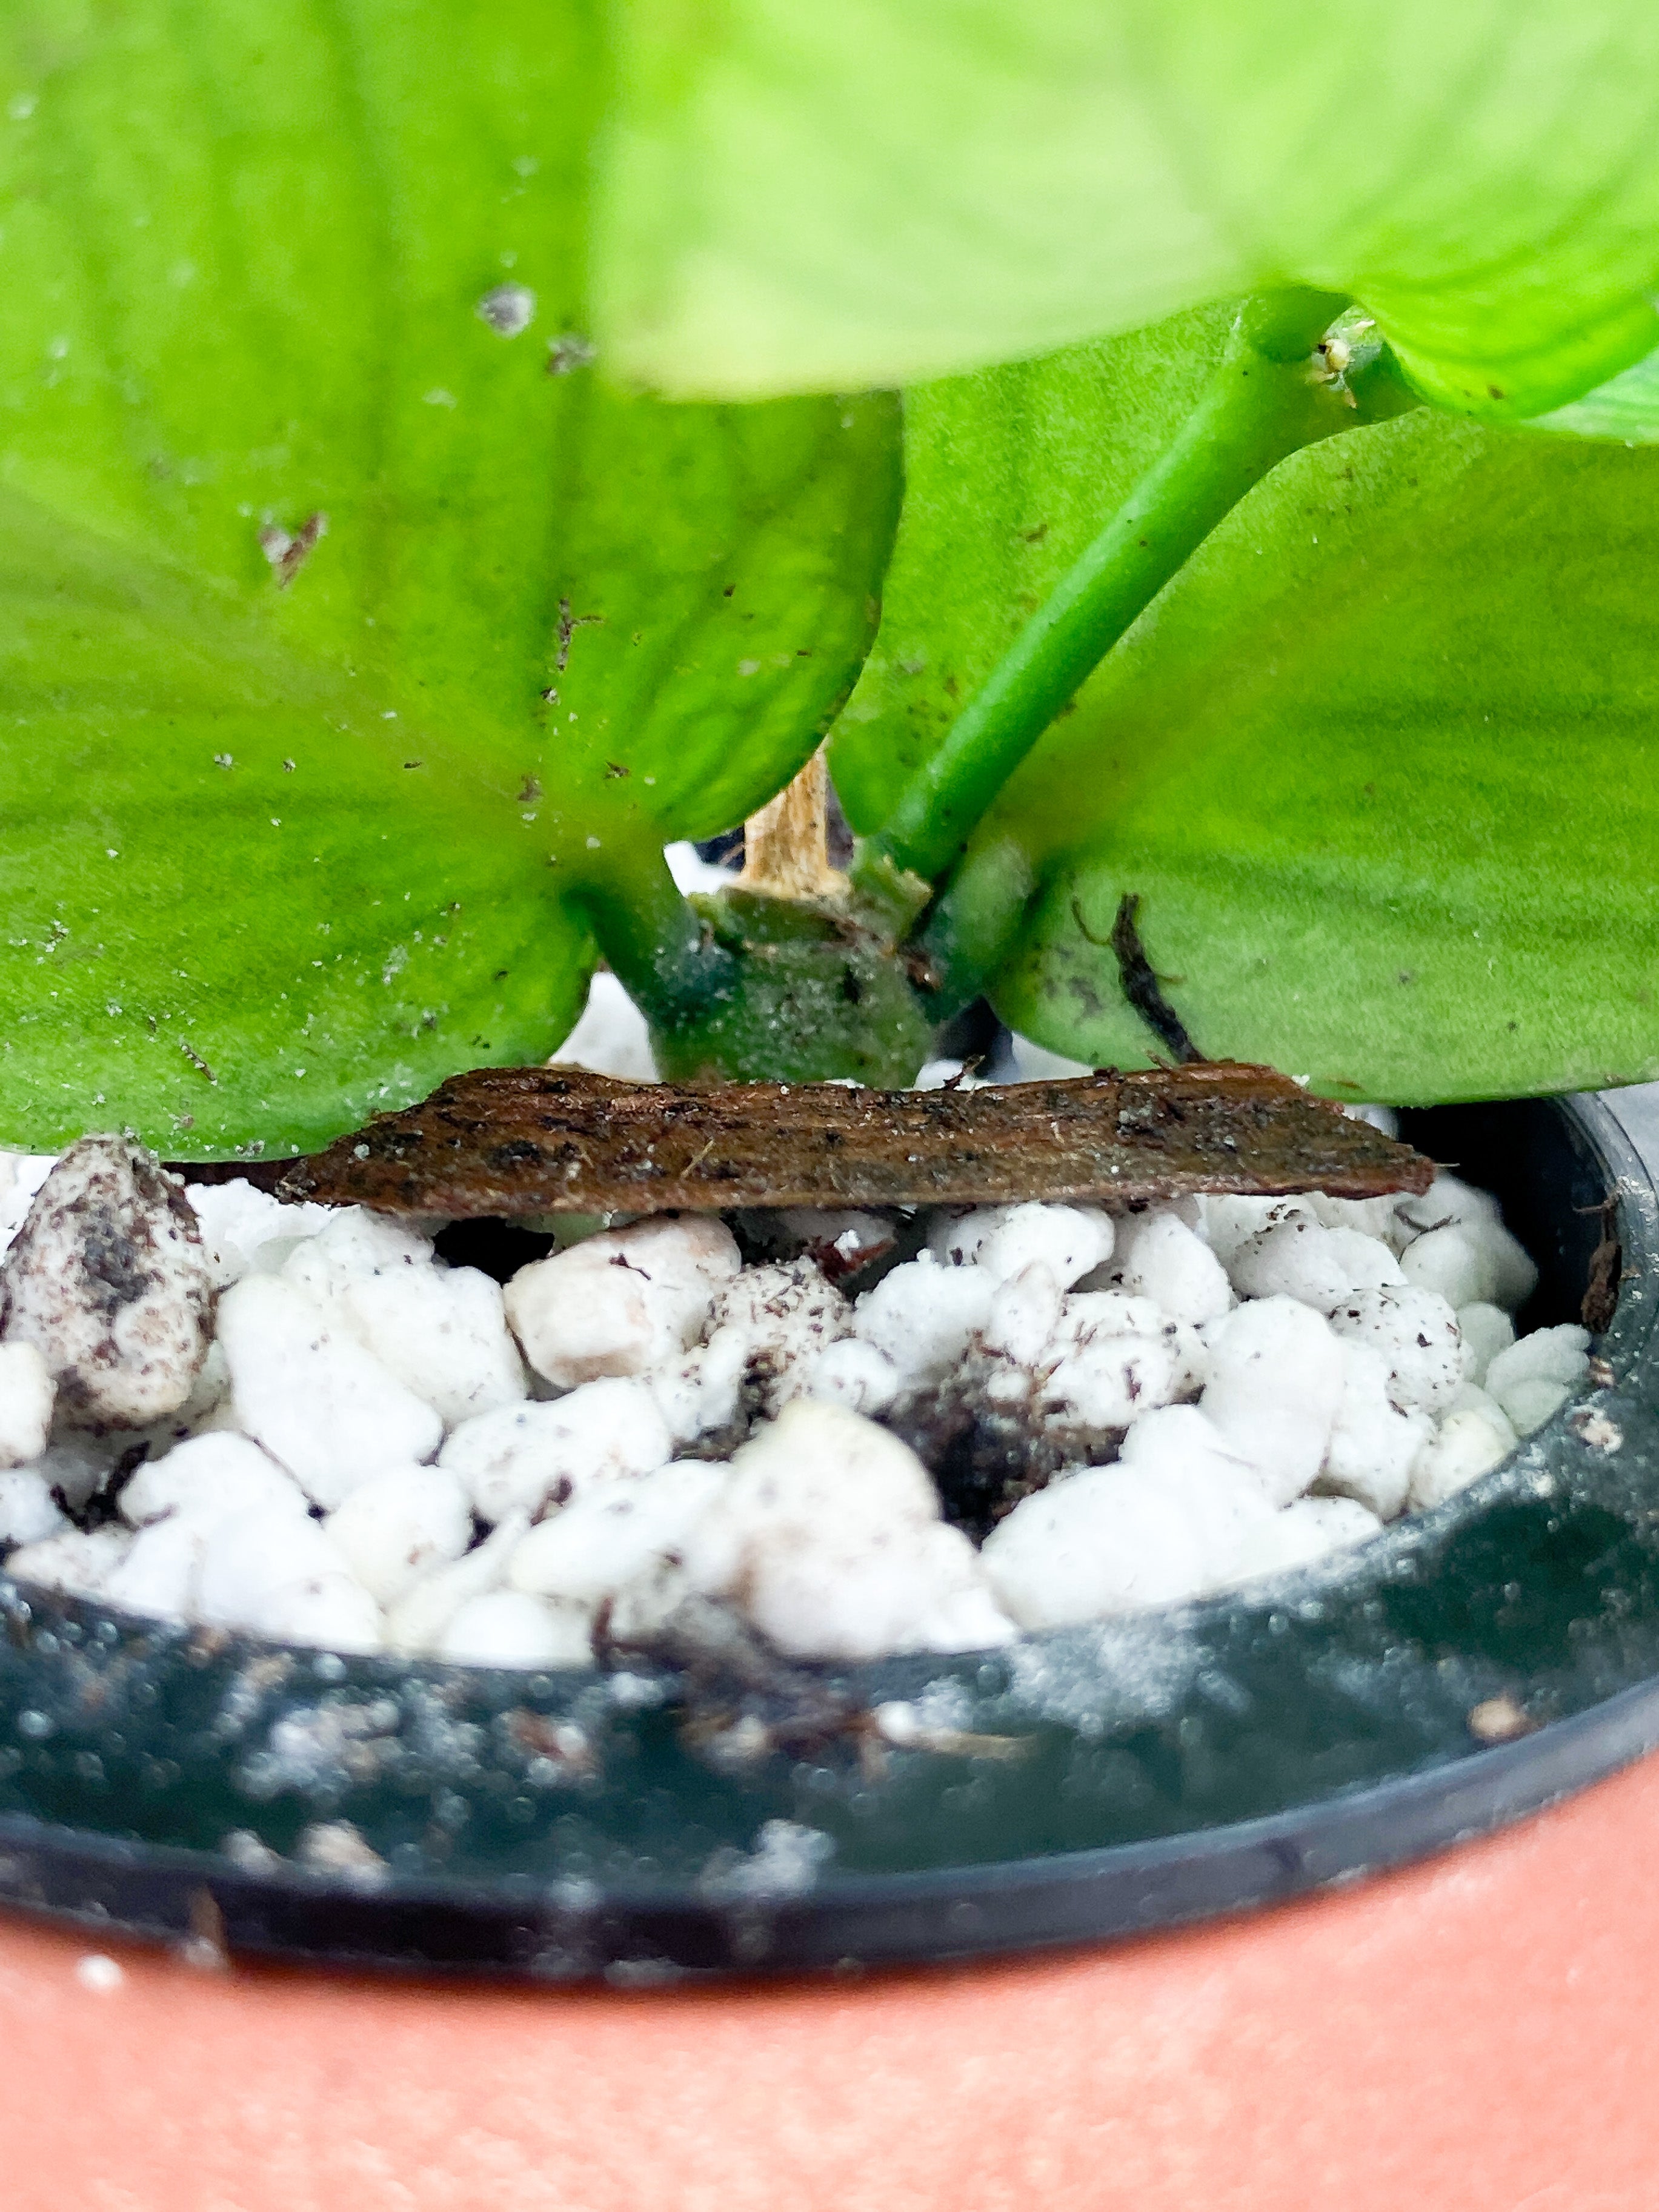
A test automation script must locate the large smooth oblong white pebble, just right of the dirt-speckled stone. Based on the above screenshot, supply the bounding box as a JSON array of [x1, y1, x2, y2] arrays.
[[219, 1274, 444, 1506]]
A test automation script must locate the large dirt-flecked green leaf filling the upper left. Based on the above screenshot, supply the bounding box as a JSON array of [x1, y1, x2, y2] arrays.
[[0, 0, 898, 1157]]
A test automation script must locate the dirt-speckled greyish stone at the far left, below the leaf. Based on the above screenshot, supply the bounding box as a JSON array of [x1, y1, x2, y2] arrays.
[[0, 1137, 212, 1429]]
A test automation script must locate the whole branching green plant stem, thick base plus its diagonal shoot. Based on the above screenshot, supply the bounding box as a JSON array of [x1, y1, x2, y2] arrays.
[[568, 292, 1415, 1081]]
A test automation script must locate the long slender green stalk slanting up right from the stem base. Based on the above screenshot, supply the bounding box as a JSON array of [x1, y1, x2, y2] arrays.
[[856, 290, 1409, 883]]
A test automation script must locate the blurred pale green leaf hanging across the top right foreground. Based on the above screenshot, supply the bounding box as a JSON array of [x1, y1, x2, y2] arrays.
[[599, 0, 1659, 416]]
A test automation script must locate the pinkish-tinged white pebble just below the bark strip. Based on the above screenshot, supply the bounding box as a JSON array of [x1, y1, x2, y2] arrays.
[[507, 1214, 741, 1389]]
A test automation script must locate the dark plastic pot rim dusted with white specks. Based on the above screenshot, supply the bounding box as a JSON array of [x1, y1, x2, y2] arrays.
[[0, 1093, 1659, 1987]]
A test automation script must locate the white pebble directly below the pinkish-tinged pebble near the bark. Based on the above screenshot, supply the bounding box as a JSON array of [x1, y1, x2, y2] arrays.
[[438, 1376, 674, 1522]]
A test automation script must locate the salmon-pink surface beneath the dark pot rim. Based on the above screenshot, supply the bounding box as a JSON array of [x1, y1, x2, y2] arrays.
[[0, 1761, 1659, 2212]]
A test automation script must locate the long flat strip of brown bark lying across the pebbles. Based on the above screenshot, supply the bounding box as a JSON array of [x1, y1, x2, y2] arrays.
[[276, 1061, 1434, 1219]]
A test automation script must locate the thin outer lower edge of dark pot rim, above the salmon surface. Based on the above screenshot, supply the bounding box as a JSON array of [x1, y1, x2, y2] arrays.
[[0, 1654, 1659, 1988]]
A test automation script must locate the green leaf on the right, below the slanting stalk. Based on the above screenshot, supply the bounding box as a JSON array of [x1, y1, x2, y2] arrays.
[[956, 414, 1659, 1101]]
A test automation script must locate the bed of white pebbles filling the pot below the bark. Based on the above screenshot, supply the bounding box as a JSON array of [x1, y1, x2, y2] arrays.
[[0, 1157, 1588, 1668]]
